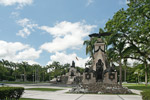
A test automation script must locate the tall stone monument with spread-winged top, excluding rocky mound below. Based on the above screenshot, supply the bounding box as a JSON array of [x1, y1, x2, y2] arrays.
[[82, 33, 117, 84]]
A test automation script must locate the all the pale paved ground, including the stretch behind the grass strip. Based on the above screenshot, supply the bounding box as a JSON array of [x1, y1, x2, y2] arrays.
[[6, 84, 142, 100]]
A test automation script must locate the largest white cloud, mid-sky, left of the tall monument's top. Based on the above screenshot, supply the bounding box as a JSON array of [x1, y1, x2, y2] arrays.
[[40, 21, 96, 53]]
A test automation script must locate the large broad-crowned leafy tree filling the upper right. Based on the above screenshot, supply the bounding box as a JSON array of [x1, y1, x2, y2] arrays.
[[105, 0, 150, 85]]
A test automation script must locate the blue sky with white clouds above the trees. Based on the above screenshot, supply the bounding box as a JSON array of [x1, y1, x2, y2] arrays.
[[0, 0, 127, 67]]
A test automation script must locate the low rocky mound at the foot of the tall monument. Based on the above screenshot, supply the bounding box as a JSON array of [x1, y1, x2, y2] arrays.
[[70, 82, 132, 94]]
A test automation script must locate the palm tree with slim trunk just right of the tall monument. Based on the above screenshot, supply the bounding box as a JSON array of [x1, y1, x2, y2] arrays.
[[108, 33, 131, 86]]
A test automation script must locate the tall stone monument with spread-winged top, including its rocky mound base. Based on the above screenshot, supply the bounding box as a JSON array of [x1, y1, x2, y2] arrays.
[[70, 32, 132, 94]]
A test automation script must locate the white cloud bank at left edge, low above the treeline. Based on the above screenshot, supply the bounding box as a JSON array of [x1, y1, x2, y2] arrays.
[[0, 40, 42, 62]]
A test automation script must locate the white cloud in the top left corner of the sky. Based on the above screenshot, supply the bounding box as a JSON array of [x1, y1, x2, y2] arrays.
[[0, 0, 33, 9]]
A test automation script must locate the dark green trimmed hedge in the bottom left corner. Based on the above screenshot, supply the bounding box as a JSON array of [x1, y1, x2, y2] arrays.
[[0, 87, 24, 100]]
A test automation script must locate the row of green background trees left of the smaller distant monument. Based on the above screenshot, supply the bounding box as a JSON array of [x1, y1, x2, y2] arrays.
[[0, 59, 74, 83]]
